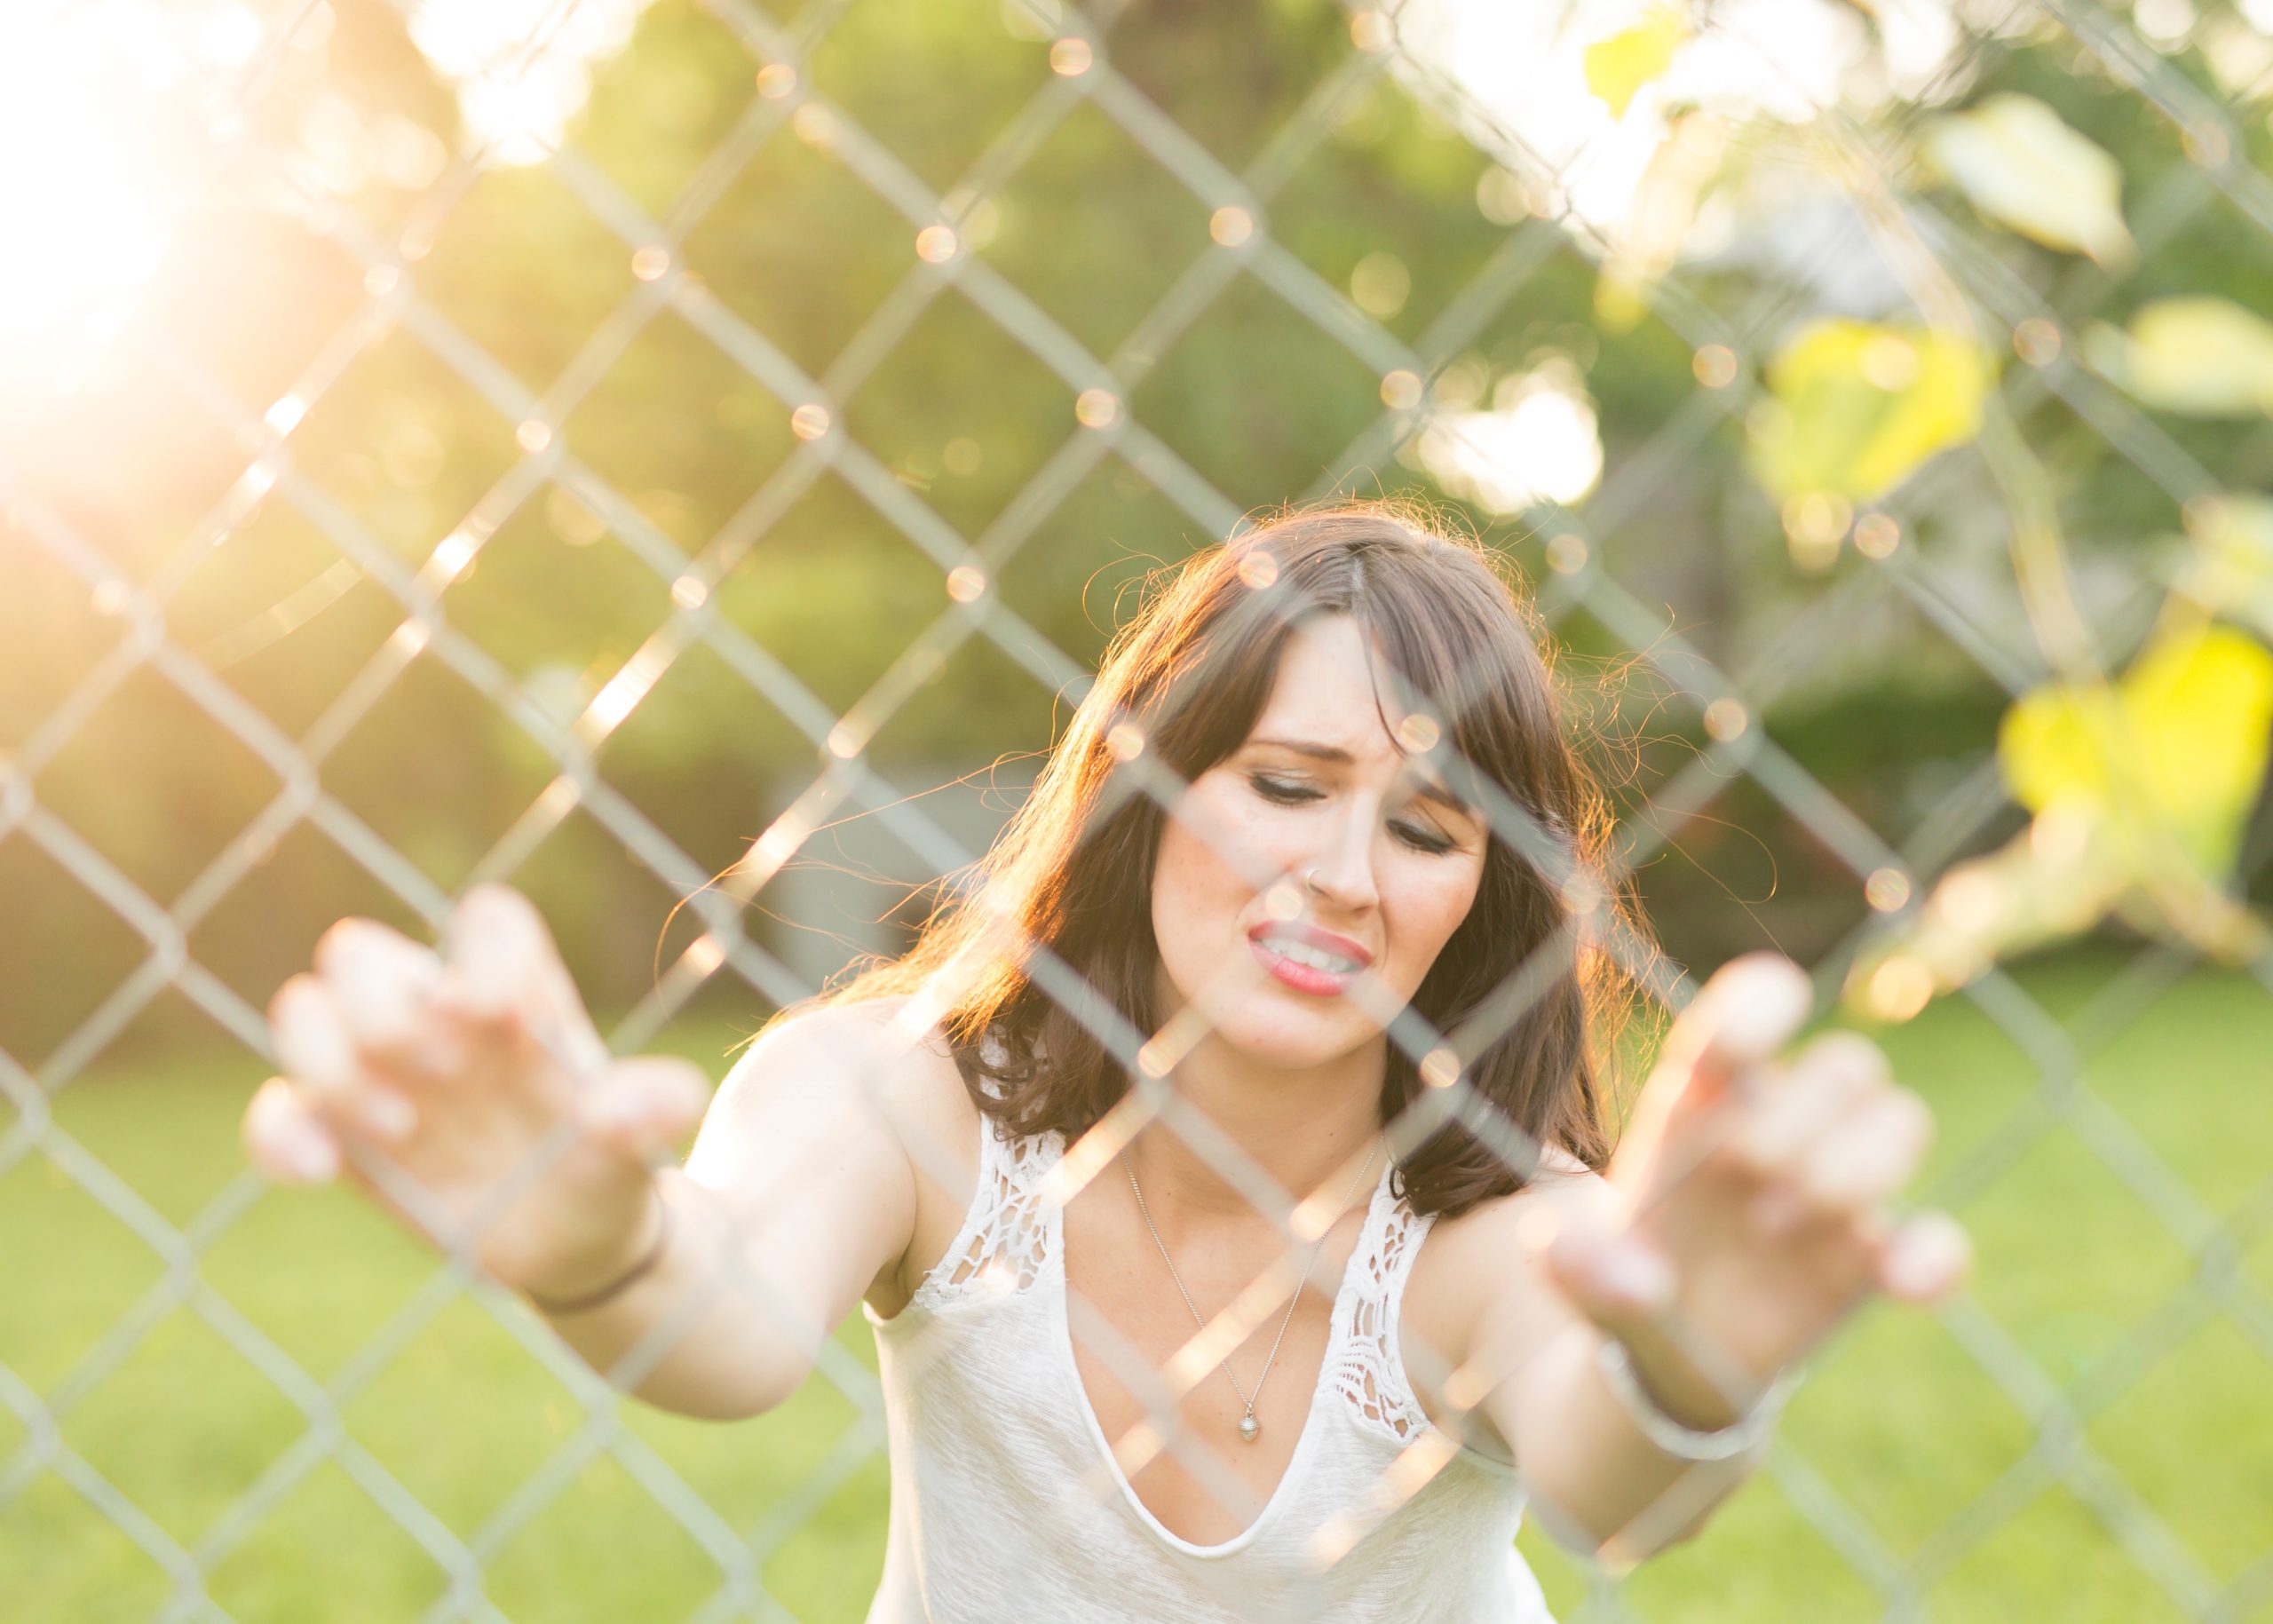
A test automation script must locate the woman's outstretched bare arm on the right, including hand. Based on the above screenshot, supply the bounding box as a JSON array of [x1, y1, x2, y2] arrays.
[[1436, 955, 1968, 1560]]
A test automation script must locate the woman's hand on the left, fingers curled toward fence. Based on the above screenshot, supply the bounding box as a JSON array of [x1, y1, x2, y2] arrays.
[[243, 883, 711, 1299]]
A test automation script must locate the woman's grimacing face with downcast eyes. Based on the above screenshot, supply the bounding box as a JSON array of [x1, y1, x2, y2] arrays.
[[1152, 614, 1486, 1069]]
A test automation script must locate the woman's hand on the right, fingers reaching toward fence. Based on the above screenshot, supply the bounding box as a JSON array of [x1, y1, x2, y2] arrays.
[[1548, 953, 1971, 1430]]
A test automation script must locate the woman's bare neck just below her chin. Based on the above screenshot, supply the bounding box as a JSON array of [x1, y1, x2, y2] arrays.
[[1128, 1018, 1387, 1228]]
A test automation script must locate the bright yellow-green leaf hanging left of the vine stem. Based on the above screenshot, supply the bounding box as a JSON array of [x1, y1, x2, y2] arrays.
[[1748, 319, 1996, 503]]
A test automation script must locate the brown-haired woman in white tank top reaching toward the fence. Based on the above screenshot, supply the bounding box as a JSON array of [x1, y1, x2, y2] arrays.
[[245, 505, 1966, 1624]]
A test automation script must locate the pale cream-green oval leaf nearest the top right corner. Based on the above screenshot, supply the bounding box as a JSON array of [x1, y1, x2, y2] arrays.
[[1925, 96, 2134, 266]]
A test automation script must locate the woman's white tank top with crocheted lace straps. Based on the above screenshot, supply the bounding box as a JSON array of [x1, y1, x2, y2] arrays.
[[861, 1114, 1552, 1624]]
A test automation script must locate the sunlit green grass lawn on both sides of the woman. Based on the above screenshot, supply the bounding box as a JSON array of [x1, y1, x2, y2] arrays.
[[0, 953, 2273, 1624]]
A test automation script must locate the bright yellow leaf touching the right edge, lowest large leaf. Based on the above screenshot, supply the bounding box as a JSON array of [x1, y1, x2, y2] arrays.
[[1998, 625, 2273, 878]]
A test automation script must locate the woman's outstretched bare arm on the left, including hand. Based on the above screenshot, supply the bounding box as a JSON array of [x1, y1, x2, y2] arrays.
[[243, 884, 939, 1417]]
